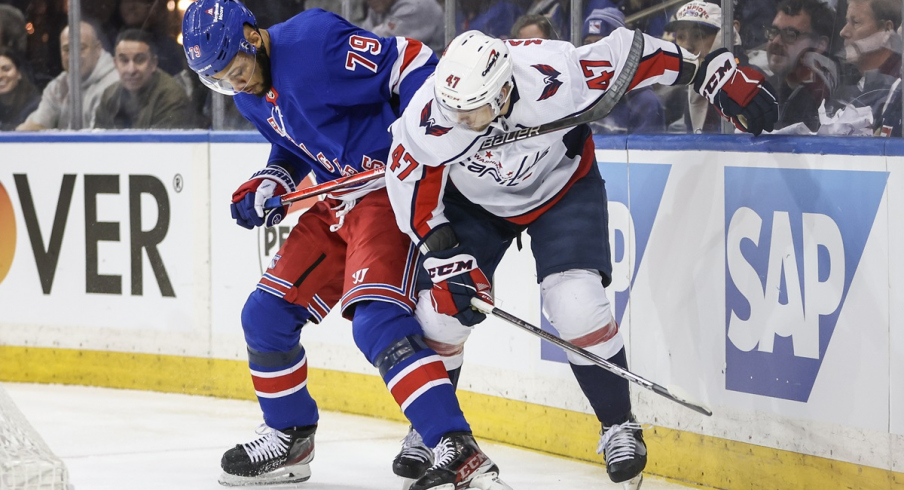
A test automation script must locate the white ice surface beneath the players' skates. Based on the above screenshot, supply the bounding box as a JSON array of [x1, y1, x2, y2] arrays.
[[3, 383, 687, 490]]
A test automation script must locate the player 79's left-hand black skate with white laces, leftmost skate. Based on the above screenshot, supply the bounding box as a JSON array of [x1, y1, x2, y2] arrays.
[[219, 425, 317, 487]]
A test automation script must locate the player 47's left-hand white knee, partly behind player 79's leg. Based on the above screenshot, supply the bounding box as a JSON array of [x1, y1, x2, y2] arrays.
[[414, 289, 471, 371]]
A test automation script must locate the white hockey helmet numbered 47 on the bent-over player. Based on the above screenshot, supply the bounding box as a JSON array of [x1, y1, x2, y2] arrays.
[[434, 31, 512, 118]]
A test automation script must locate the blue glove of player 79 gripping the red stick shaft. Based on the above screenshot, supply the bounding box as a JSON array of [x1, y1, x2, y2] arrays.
[[231, 165, 295, 230]]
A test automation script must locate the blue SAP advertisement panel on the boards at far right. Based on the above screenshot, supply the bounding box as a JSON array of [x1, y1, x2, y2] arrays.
[[725, 167, 888, 402]]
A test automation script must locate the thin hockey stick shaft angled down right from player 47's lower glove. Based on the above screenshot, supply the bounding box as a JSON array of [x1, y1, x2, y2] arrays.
[[471, 298, 713, 416]]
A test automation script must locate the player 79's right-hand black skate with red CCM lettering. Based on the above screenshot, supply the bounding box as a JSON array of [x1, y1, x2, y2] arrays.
[[411, 432, 512, 490]]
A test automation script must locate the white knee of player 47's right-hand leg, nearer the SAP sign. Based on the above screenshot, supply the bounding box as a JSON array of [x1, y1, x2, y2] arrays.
[[540, 269, 625, 366]]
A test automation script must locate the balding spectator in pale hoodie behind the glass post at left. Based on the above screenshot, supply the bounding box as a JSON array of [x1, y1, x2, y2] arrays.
[[16, 21, 119, 131]]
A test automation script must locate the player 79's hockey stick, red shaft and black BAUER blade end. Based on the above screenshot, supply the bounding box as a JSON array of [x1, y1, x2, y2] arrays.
[[264, 29, 644, 209]]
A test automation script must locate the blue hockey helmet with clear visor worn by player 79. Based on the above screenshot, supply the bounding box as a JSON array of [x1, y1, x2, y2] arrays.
[[182, 0, 257, 95]]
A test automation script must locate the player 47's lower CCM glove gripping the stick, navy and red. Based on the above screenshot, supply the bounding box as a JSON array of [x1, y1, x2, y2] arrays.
[[424, 247, 493, 327]]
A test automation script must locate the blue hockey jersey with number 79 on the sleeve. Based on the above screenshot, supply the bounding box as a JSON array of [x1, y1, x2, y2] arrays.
[[234, 9, 436, 199]]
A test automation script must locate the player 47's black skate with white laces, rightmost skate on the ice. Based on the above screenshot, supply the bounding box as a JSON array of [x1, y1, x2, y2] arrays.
[[596, 417, 647, 482]]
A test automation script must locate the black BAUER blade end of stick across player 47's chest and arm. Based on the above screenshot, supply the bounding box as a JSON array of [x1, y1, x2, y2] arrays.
[[480, 29, 644, 150]]
